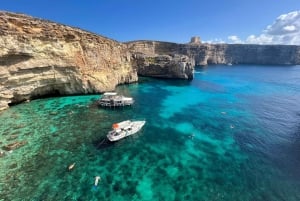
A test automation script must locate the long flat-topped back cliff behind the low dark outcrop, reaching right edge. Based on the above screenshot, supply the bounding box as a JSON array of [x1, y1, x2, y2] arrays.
[[127, 41, 300, 66]]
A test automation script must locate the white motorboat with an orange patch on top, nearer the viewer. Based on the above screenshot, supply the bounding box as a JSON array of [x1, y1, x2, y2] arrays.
[[107, 120, 146, 142]]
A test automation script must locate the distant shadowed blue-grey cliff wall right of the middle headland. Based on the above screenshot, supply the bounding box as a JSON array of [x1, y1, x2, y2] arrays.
[[183, 44, 300, 65]]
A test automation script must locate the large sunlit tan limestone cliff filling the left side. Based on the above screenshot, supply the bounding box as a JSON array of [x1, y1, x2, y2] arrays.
[[0, 12, 138, 110]]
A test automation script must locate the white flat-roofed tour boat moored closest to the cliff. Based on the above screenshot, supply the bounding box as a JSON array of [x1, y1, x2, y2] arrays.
[[98, 92, 134, 107]]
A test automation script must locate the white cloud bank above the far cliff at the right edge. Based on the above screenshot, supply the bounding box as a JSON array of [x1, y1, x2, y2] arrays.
[[228, 10, 300, 45]]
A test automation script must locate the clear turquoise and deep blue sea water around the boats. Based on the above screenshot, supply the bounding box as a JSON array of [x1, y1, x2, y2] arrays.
[[0, 66, 300, 201]]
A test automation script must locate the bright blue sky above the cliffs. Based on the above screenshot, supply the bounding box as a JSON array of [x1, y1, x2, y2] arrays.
[[0, 0, 300, 44]]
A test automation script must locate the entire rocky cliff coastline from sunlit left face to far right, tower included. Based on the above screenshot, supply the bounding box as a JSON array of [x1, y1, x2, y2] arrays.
[[0, 12, 300, 110]]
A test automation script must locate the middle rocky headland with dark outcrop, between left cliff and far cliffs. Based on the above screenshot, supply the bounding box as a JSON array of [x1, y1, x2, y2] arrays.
[[126, 41, 195, 79]]
